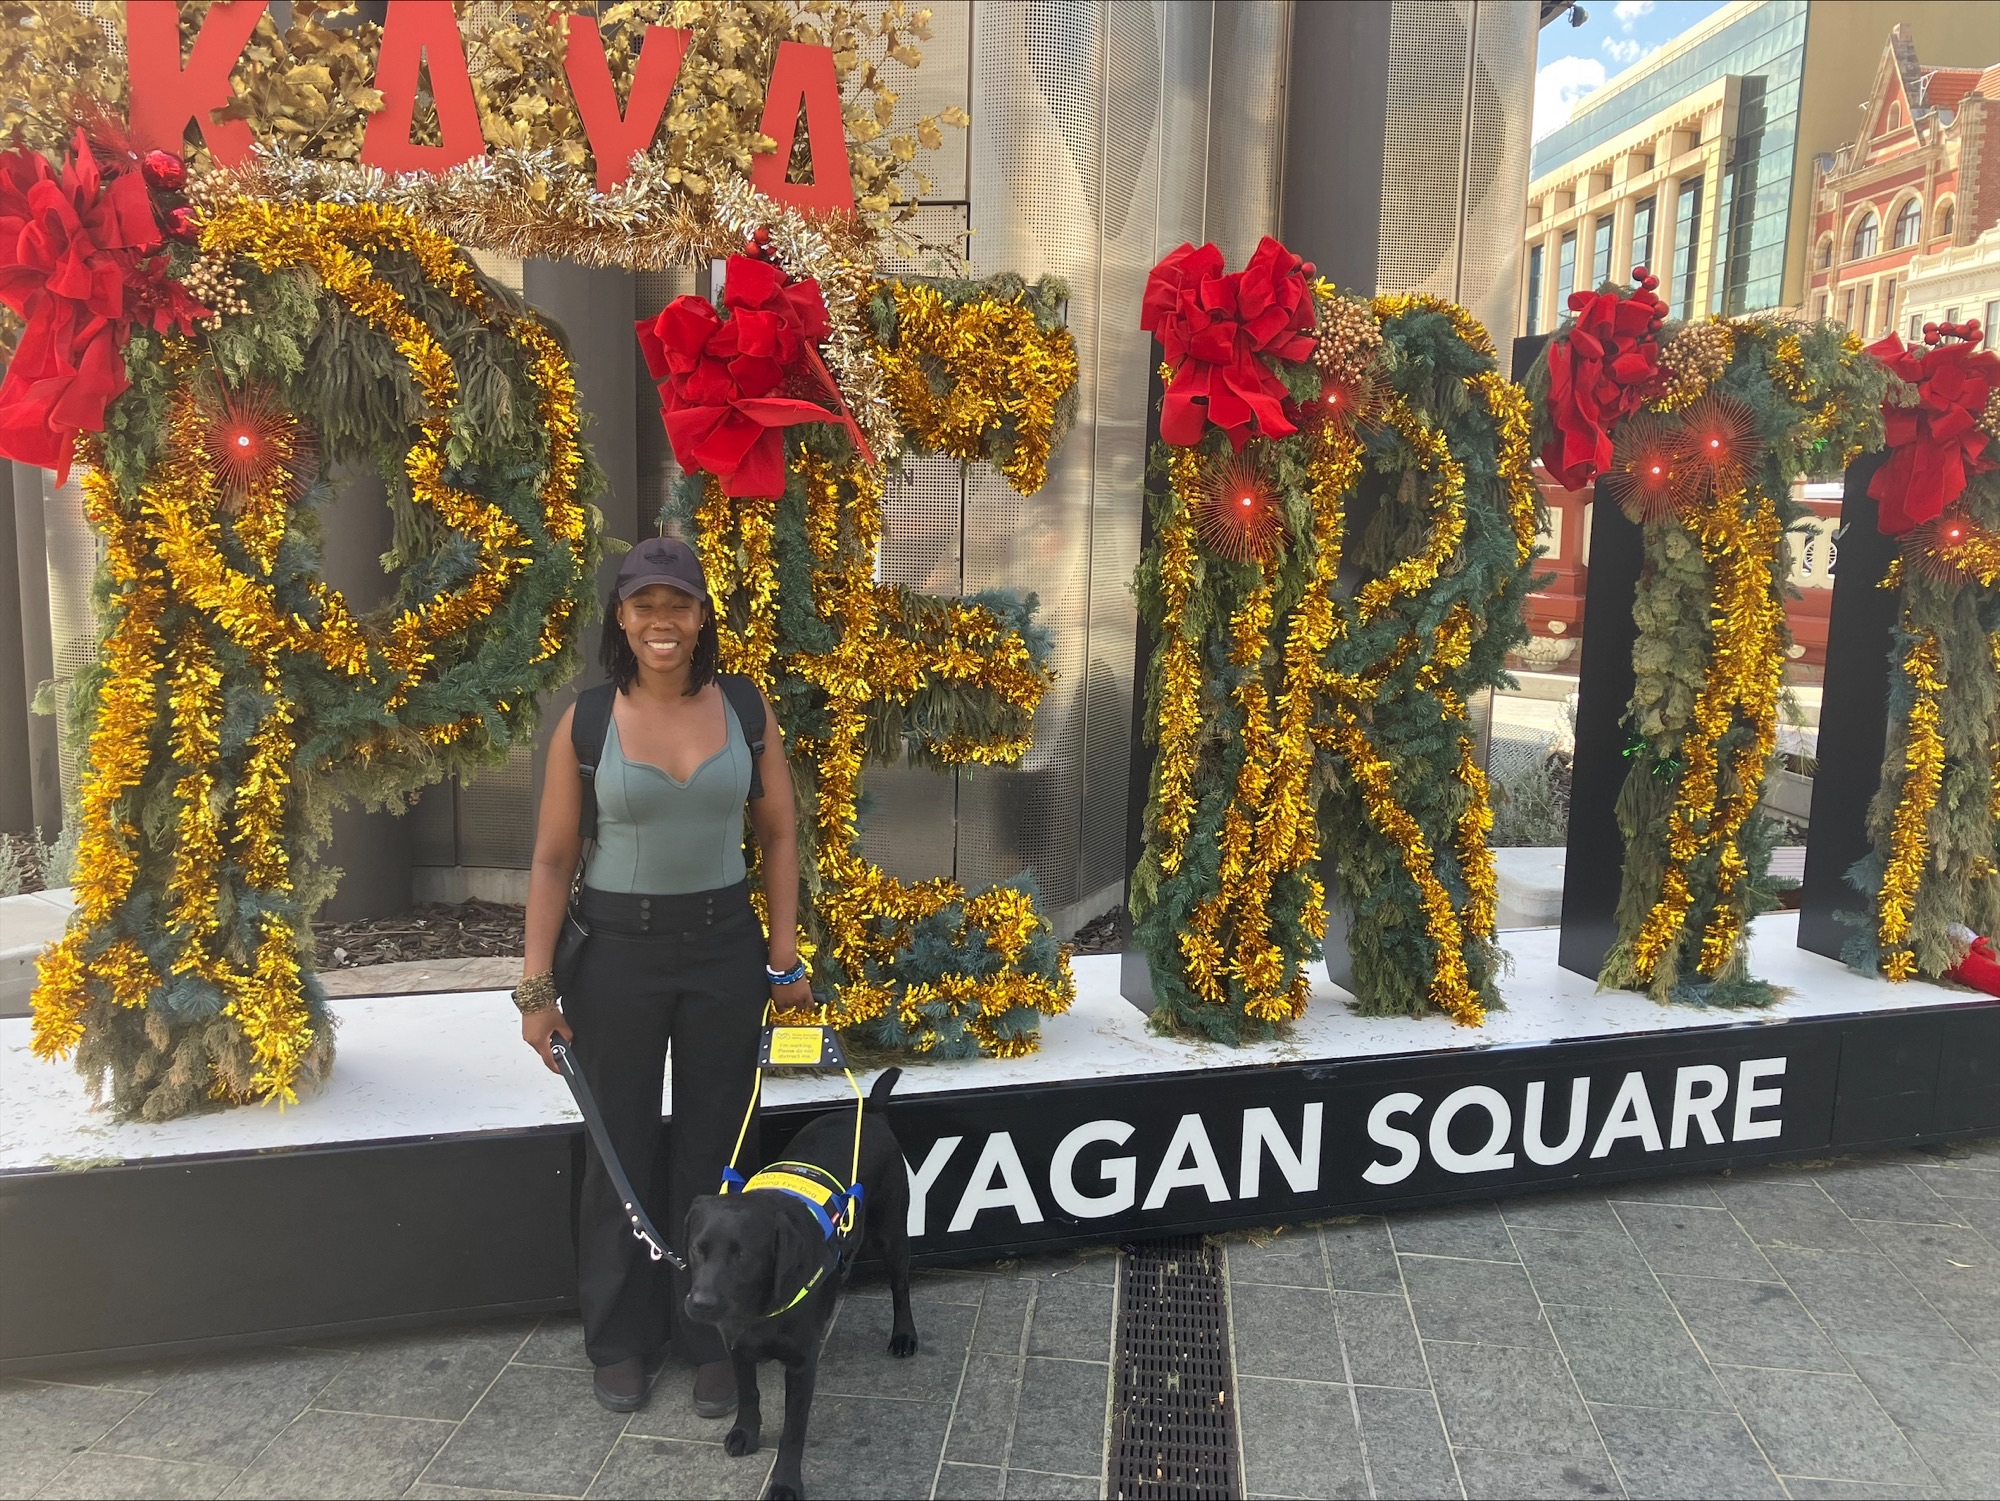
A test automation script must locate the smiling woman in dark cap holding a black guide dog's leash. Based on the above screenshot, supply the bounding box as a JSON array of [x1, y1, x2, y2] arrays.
[[514, 536, 810, 1417]]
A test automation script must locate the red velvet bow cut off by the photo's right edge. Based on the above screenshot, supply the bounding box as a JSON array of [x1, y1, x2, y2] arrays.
[[1868, 334, 2000, 536]]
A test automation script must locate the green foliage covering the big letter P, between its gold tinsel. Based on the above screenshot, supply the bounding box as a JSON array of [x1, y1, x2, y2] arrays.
[[58, 226, 604, 1121]]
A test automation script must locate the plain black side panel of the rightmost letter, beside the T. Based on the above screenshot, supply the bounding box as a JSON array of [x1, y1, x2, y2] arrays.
[[1798, 454, 1902, 959]]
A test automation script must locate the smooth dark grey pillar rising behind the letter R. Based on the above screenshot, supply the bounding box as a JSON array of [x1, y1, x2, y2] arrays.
[[1278, 0, 1390, 292]]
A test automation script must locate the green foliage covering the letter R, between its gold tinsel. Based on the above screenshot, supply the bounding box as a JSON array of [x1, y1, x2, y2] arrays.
[[1132, 298, 1536, 1043]]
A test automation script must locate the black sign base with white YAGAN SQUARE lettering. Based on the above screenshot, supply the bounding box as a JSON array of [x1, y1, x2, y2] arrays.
[[0, 997, 2000, 1373]]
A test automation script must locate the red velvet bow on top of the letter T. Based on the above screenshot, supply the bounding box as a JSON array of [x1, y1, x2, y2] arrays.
[[1542, 276, 1666, 490]]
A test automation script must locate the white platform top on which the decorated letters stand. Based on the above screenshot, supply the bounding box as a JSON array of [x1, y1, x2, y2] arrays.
[[0, 913, 1986, 1173]]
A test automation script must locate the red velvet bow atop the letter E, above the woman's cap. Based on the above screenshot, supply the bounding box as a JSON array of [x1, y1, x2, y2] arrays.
[[638, 256, 874, 498]]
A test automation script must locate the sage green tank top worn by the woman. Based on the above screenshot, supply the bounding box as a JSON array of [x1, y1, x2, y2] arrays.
[[584, 704, 750, 897]]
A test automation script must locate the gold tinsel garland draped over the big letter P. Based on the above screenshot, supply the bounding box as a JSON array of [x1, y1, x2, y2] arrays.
[[34, 202, 588, 1099]]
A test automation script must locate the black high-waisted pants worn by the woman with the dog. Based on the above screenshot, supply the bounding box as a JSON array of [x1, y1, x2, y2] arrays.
[[562, 885, 770, 1365]]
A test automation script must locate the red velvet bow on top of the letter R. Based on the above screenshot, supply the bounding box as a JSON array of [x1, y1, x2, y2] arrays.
[[1138, 234, 1318, 452]]
